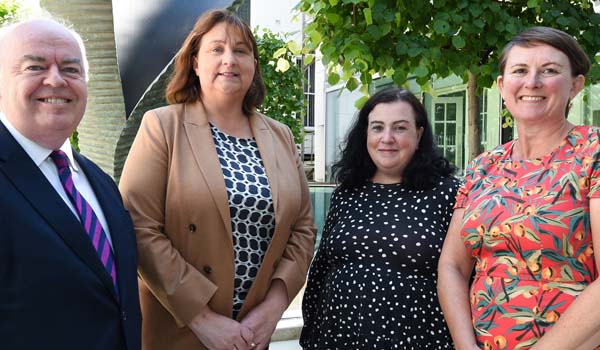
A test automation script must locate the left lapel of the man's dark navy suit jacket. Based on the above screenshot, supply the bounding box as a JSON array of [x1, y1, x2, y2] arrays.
[[0, 123, 114, 298]]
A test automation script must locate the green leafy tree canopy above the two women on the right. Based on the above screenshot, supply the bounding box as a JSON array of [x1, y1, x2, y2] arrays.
[[299, 0, 600, 101]]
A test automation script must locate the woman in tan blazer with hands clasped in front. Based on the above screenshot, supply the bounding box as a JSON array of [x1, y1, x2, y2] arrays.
[[120, 10, 316, 350]]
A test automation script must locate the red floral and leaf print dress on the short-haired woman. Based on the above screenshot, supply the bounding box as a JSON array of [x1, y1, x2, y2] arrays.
[[455, 126, 600, 350]]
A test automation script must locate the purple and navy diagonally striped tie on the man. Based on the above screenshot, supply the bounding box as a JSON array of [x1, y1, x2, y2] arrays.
[[50, 151, 117, 290]]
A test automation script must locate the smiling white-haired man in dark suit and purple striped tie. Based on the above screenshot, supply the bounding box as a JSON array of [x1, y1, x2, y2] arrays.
[[0, 20, 141, 350]]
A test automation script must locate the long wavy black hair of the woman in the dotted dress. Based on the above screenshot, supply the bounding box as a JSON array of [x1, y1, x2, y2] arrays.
[[332, 87, 456, 190]]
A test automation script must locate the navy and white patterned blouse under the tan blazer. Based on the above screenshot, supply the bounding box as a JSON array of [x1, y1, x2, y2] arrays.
[[211, 125, 275, 318]]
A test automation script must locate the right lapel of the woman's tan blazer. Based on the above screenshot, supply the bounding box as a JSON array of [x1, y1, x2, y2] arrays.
[[250, 113, 279, 215]]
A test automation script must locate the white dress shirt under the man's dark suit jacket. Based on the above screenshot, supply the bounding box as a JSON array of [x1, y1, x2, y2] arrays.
[[0, 112, 112, 248]]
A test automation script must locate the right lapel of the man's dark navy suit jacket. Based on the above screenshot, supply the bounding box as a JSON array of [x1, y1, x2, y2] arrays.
[[73, 152, 126, 297]]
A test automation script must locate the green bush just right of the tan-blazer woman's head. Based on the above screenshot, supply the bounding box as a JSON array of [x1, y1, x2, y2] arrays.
[[254, 28, 305, 144]]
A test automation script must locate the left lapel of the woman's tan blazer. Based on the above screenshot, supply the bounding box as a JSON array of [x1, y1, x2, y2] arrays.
[[184, 102, 233, 241]]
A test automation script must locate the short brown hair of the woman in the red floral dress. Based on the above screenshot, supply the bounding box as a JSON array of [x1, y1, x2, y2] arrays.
[[498, 27, 591, 77]]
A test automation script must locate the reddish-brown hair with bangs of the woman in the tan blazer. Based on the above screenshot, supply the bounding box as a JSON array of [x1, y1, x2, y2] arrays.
[[166, 10, 266, 115]]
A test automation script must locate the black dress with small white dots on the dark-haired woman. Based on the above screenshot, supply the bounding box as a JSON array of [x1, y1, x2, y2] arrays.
[[300, 178, 459, 350]]
